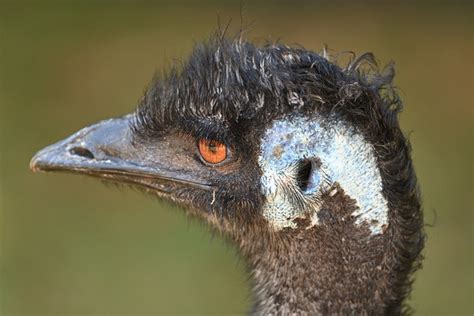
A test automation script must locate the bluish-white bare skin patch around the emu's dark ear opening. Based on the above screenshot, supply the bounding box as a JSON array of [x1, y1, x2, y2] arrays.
[[258, 116, 388, 234]]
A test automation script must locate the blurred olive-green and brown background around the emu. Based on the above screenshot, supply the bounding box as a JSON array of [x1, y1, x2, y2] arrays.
[[0, 1, 474, 315]]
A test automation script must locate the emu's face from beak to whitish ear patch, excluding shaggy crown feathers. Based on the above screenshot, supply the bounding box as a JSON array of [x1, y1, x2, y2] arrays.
[[31, 111, 387, 238]]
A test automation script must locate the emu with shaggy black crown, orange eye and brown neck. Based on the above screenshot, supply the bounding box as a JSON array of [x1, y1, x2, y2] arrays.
[[30, 36, 424, 315]]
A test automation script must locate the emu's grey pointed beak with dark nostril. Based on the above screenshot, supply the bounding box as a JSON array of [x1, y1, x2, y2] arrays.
[[30, 115, 211, 193]]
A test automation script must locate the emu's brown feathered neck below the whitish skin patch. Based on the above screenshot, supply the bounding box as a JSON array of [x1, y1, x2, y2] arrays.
[[234, 189, 406, 315]]
